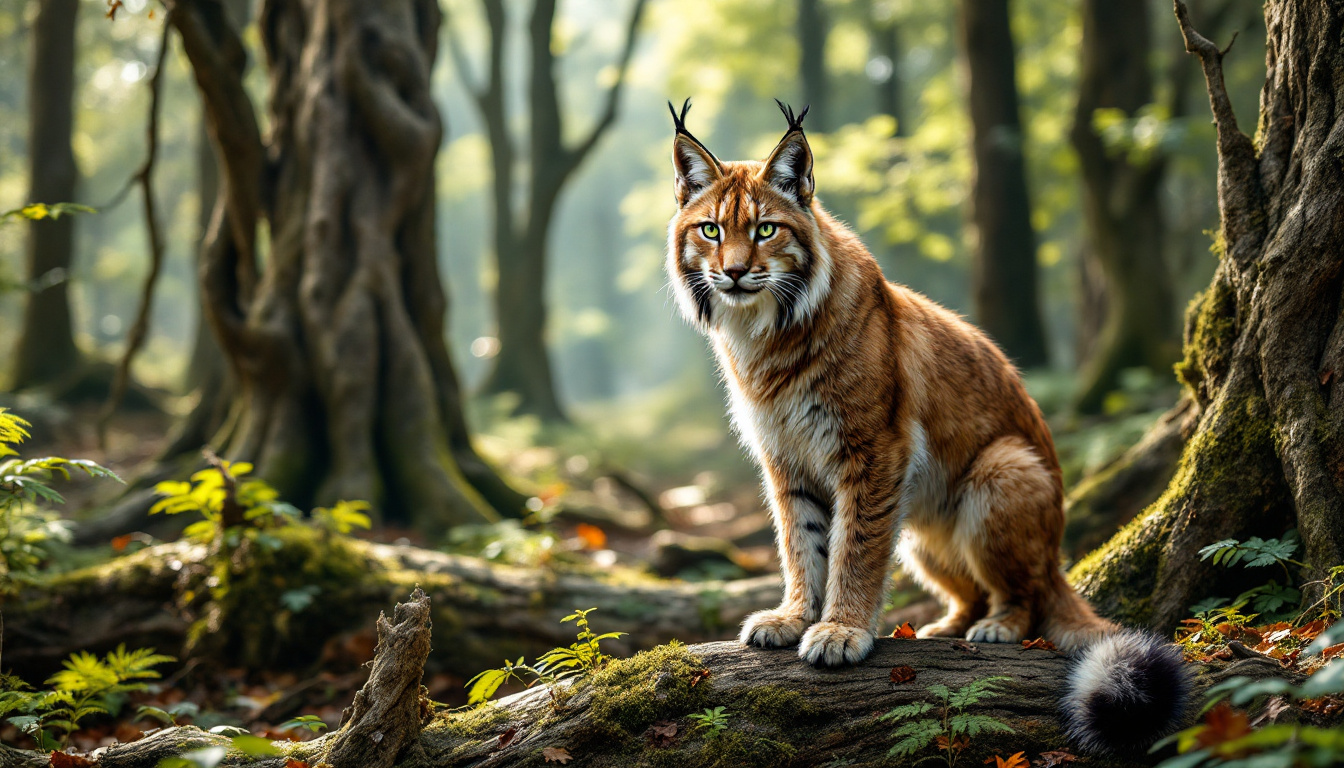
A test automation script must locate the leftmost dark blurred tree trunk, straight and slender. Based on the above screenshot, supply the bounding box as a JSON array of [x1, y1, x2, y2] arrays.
[[9, 0, 81, 390]]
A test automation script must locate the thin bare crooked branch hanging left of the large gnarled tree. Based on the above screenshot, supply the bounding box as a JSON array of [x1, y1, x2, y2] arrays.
[[97, 16, 173, 447]]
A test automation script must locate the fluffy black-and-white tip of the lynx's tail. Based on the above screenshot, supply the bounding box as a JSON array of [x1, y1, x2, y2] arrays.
[[1063, 629, 1193, 755]]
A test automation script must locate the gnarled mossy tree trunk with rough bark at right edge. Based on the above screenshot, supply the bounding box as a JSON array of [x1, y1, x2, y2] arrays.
[[1071, 0, 1344, 629]]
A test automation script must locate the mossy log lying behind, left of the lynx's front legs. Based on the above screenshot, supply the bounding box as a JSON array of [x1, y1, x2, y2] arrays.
[[4, 526, 780, 679]]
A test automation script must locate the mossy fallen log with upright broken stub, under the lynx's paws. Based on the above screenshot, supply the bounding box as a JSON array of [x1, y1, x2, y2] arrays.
[[28, 590, 1220, 768]]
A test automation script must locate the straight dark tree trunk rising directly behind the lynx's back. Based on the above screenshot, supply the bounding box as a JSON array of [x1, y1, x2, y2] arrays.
[[958, 0, 1050, 367]]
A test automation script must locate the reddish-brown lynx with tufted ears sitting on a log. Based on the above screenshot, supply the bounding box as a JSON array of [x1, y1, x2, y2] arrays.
[[667, 100, 1185, 749]]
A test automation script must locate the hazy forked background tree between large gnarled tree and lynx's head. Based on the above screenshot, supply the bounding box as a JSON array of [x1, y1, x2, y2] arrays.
[[449, 0, 646, 421]]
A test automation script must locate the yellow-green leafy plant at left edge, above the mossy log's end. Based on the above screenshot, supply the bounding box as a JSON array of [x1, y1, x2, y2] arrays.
[[0, 408, 121, 594]]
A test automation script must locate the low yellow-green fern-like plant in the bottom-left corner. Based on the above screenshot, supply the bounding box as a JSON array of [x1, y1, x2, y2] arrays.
[[0, 646, 175, 751]]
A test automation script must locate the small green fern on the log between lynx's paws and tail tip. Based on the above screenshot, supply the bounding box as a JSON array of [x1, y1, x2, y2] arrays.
[[880, 677, 1013, 768]]
